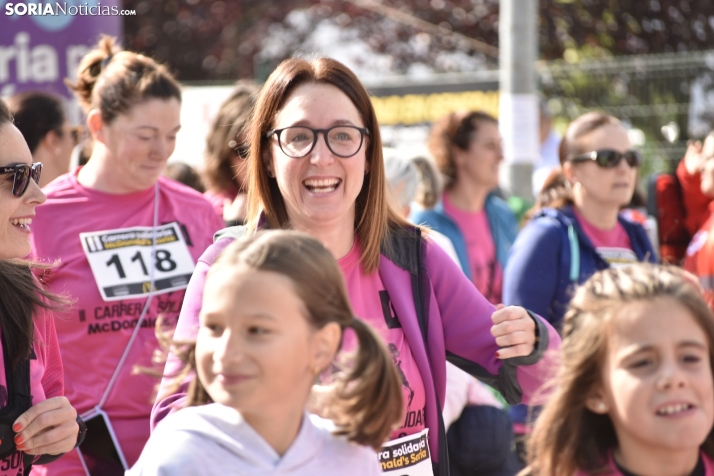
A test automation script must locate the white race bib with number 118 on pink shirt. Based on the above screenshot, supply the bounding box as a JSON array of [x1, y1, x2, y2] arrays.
[[79, 222, 194, 301]]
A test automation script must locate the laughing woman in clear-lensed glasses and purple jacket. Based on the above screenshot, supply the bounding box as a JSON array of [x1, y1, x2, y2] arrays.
[[153, 58, 560, 474]]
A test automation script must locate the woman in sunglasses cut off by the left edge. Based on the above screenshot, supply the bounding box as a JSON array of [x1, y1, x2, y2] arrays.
[[0, 99, 84, 476]]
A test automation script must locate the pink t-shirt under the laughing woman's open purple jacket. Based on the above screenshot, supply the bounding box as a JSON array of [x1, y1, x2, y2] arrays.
[[339, 239, 426, 439]]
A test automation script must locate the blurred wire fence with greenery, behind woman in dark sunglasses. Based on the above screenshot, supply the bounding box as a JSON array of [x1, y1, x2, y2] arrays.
[[538, 50, 714, 173]]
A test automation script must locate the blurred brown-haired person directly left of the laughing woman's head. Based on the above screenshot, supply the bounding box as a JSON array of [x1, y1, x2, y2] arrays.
[[203, 81, 258, 226]]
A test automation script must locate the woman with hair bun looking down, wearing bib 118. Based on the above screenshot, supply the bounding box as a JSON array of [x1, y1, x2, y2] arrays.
[[32, 38, 222, 475]]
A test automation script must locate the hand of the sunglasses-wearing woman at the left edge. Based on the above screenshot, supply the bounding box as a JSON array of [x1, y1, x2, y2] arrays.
[[12, 397, 79, 455]]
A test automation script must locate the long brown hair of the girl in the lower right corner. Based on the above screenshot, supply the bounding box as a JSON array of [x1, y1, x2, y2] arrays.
[[523, 263, 714, 476]]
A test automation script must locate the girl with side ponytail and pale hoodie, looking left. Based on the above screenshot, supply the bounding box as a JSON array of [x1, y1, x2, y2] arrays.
[[128, 231, 402, 476]]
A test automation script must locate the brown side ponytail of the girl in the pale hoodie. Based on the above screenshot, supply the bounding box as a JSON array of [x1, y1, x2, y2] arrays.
[[327, 318, 404, 449]]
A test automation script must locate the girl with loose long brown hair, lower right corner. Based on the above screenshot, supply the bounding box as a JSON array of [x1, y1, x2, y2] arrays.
[[523, 264, 714, 476]]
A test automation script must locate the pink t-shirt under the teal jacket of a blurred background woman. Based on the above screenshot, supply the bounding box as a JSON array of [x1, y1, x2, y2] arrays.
[[443, 194, 503, 304]]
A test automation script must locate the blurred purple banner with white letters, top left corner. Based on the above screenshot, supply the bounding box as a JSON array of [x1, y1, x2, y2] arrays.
[[0, 0, 123, 98]]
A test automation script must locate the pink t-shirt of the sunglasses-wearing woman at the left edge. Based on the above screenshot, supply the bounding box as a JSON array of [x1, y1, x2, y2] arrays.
[[0, 310, 64, 476]]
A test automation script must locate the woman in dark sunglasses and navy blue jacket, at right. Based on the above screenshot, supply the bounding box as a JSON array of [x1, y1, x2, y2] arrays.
[[503, 112, 657, 457]]
